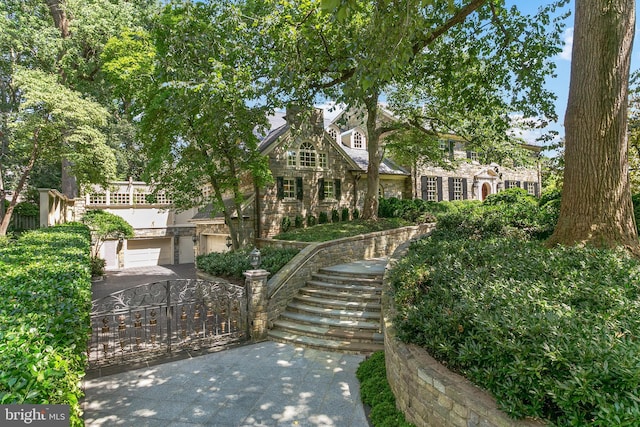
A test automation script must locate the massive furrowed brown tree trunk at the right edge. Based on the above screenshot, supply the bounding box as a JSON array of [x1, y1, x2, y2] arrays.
[[549, 0, 638, 253]]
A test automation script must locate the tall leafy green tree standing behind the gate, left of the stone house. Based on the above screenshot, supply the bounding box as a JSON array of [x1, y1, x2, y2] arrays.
[[141, 0, 271, 249]]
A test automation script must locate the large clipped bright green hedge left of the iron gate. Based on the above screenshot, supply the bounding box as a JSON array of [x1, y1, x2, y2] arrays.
[[0, 224, 91, 426]]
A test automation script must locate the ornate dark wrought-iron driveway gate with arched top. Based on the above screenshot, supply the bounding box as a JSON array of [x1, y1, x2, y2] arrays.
[[88, 279, 248, 369]]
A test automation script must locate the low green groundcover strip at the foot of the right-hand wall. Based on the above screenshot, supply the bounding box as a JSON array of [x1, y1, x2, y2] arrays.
[[356, 351, 413, 427]]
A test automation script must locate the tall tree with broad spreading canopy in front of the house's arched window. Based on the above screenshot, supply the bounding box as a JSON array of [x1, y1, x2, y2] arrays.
[[255, 0, 565, 218]]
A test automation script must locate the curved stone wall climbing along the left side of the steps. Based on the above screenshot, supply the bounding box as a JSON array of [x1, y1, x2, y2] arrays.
[[261, 224, 434, 325]]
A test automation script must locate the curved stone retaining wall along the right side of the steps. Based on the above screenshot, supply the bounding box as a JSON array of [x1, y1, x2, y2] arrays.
[[382, 243, 544, 427]]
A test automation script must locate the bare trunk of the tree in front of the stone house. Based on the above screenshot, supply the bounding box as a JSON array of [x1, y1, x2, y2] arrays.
[[362, 92, 382, 220]]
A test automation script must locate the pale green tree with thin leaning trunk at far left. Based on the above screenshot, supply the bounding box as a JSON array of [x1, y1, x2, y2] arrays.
[[0, 67, 115, 235]]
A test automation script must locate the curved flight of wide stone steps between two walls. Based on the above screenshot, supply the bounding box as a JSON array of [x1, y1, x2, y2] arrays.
[[269, 260, 386, 354]]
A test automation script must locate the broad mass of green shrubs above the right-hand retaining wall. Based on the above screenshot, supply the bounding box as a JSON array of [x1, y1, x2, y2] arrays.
[[391, 231, 640, 426]]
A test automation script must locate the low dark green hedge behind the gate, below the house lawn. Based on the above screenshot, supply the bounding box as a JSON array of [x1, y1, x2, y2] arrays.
[[196, 246, 300, 282]]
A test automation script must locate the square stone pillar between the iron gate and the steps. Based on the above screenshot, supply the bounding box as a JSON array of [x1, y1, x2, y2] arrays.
[[243, 270, 269, 342]]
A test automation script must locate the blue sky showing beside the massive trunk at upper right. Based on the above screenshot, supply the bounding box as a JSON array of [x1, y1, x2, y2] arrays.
[[506, 0, 640, 150]]
